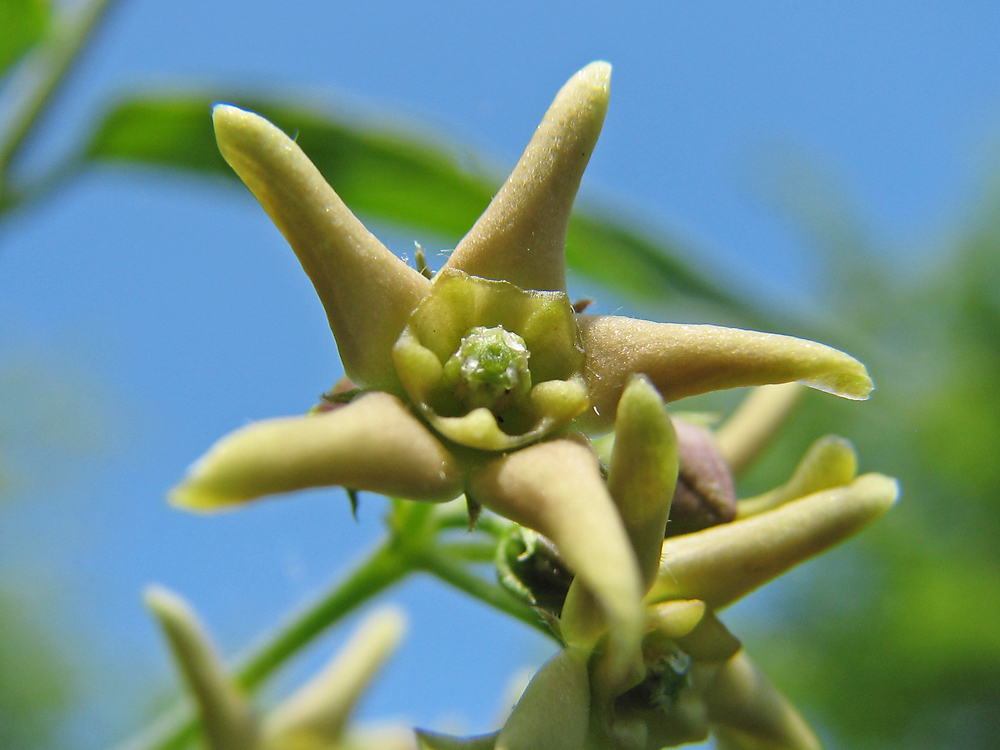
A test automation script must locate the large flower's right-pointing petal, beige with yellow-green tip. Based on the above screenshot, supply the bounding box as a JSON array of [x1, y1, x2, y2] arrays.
[[577, 315, 873, 433]]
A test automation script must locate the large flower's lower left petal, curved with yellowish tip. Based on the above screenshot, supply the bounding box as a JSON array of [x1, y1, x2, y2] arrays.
[[170, 393, 465, 510]]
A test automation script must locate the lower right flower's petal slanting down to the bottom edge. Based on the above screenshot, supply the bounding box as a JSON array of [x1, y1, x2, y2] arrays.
[[705, 651, 823, 750]]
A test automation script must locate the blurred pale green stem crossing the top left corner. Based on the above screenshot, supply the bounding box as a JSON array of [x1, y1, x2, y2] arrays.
[[0, 0, 114, 179]]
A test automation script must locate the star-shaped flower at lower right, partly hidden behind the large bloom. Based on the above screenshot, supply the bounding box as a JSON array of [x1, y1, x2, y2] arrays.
[[418, 378, 898, 750]]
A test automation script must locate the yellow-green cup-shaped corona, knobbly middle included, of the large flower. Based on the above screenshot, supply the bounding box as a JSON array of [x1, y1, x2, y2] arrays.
[[393, 269, 588, 451]]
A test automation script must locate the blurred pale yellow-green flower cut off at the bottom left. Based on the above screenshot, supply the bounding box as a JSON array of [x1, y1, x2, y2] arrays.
[[146, 586, 413, 750]]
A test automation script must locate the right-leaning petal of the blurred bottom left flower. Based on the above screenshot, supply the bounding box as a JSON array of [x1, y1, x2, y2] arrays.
[[263, 607, 406, 750]]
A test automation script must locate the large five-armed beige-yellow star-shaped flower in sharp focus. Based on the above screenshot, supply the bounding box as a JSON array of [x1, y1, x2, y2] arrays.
[[172, 62, 872, 672]]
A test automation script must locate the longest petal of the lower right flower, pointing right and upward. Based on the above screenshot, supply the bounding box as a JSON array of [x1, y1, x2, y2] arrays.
[[646, 474, 899, 610]]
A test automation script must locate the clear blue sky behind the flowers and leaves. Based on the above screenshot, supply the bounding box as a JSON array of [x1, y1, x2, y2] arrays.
[[0, 0, 1000, 748]]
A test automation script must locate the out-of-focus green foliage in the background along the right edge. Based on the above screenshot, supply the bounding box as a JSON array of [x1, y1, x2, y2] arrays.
[[741, 156, 1000, 750]]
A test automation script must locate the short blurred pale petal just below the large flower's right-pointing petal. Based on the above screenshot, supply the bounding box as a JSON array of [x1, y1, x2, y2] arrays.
[[715, 383, 803, 474]]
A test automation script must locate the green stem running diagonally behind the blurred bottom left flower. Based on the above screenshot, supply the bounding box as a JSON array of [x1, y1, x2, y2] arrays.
[[117, 538, 413, 750]]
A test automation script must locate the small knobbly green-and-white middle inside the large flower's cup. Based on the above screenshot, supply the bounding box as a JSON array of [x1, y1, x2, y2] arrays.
[[444, 326, 531, 413]]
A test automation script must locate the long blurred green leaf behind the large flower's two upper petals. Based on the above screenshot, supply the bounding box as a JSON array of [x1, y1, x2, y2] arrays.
[[85, 96, 750, 318]]
